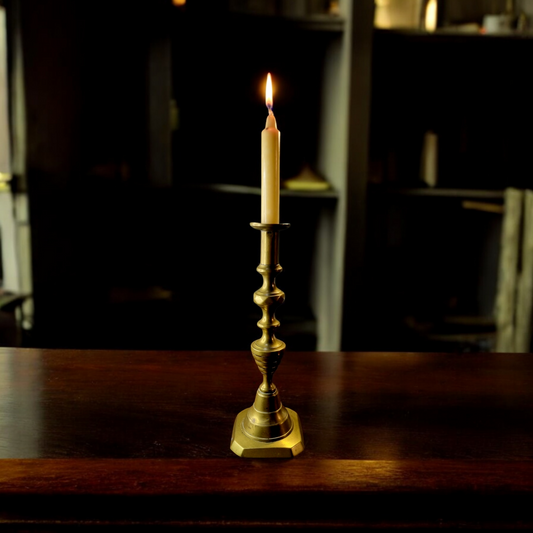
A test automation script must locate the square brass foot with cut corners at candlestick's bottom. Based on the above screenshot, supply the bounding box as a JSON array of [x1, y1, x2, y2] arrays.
[[230, 408, 304, 459]]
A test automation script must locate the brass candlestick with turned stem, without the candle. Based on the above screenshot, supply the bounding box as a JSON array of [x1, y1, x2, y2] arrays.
[[230, 222, 304, 458]]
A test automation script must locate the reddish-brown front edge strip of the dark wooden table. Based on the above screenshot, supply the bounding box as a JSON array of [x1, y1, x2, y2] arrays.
[[0, 458, 533, 496]]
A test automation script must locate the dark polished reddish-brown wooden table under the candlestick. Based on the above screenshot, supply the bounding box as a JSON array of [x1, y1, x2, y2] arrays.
[[0, 348, 533, 531]]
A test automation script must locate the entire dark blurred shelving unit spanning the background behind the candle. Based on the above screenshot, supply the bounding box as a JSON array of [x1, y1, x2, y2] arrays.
[[7, 0, 533, 351]]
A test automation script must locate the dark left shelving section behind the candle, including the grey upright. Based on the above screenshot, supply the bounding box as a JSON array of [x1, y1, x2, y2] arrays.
[[14, 0, 374, 350]]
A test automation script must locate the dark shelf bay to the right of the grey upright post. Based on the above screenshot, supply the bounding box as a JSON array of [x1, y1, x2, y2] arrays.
[[366, 26, 533, 351]]
